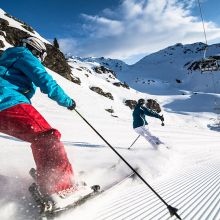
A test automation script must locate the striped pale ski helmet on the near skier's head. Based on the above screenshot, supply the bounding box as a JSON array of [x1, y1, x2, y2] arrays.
[[21, 37, 47, 62]]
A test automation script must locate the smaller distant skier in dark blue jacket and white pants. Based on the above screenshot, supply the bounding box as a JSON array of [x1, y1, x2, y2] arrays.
[[133, 99, 164, 148]]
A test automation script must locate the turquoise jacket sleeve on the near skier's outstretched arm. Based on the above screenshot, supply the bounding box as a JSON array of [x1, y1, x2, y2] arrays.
[[14, 53, 72, 107]]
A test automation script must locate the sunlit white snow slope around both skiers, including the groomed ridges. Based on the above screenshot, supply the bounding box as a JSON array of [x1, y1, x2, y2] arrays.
[[0, 67, 220, 220]]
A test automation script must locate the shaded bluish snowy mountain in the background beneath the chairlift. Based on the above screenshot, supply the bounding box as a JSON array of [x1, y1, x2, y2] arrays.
[[118, 43, 220, 94]]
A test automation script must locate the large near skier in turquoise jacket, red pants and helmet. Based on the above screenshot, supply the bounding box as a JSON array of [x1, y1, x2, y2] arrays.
[[0, 37, 87, 209]]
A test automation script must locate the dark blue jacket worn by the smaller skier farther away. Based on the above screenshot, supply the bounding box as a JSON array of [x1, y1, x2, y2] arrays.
[[133, 104, 161, 128]]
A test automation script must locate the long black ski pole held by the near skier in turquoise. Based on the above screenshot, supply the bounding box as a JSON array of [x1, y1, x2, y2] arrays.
[[74, 109, 181, 220]]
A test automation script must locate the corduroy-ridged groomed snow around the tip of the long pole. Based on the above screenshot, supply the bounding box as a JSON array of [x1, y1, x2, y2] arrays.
[[90, 160, 220, 220]]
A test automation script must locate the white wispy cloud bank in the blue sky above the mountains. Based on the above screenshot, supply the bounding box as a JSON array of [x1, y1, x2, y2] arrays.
[[60, 0, 220, 63]]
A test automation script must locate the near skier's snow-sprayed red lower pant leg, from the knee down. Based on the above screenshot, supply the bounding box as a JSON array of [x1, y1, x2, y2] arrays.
[[31, 129, 74, 194]]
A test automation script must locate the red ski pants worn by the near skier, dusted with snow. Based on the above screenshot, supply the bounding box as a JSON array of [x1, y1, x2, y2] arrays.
[[0, 104, 74, 194]]
